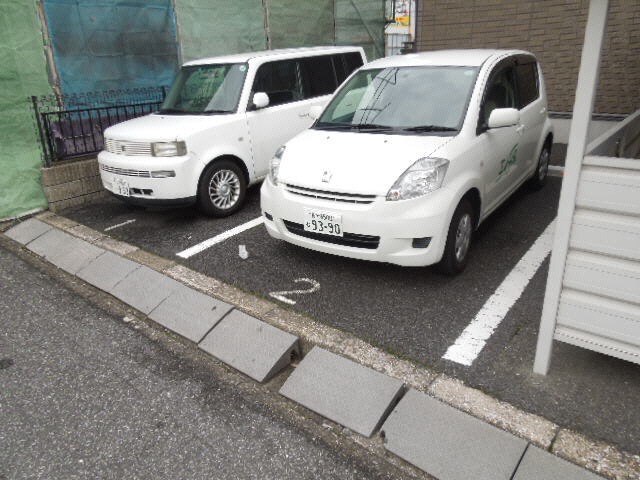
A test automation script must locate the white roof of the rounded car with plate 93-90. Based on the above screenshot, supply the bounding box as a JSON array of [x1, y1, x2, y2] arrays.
[[363, 49, 531, 69]]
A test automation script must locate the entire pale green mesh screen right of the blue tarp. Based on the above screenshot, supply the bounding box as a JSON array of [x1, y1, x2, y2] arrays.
[[175, 0, 384, 62]]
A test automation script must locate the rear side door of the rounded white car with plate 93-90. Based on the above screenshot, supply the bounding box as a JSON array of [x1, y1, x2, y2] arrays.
[[515, 55, 547, 182]]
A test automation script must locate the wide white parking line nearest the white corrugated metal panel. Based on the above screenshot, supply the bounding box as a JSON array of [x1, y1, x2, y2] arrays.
[[442, 220, 555, 366]]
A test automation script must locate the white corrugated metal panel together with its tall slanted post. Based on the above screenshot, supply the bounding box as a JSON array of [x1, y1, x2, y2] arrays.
[[534, 0, 640, 374]]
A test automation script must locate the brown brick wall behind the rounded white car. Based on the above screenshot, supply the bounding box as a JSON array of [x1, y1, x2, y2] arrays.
[[416, 0, 640, 114]]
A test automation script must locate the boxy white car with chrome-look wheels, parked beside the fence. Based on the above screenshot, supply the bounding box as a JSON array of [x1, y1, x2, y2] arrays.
[[98, 47, 366, 216]]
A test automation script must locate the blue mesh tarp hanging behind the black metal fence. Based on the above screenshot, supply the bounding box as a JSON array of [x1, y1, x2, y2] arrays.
[[42, 0, 178, 94]]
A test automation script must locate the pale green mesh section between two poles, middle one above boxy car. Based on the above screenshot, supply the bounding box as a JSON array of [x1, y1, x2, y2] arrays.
[[266, 0, 334, 48]]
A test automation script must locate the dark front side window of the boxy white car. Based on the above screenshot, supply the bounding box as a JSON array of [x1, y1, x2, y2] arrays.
[[252, 60, 302, 107]]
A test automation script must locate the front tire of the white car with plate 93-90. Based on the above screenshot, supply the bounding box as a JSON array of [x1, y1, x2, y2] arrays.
[[437, 198, 476, 275]]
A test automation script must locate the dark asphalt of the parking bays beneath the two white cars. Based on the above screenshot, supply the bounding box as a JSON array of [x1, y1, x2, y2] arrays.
[[57, 177, 640, 452]]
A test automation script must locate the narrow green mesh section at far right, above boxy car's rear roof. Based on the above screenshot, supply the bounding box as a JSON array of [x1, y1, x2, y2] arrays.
[[335, 0, 385, 60]]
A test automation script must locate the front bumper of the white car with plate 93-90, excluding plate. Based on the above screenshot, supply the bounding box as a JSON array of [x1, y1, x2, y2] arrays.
[[260, 180, 454, 266]]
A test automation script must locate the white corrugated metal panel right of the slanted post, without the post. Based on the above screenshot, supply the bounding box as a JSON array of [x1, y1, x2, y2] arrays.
[[554, 152, 640, 362]]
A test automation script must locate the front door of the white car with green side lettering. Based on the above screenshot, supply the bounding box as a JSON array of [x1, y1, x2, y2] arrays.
[[477, 61, 522, 213]]
